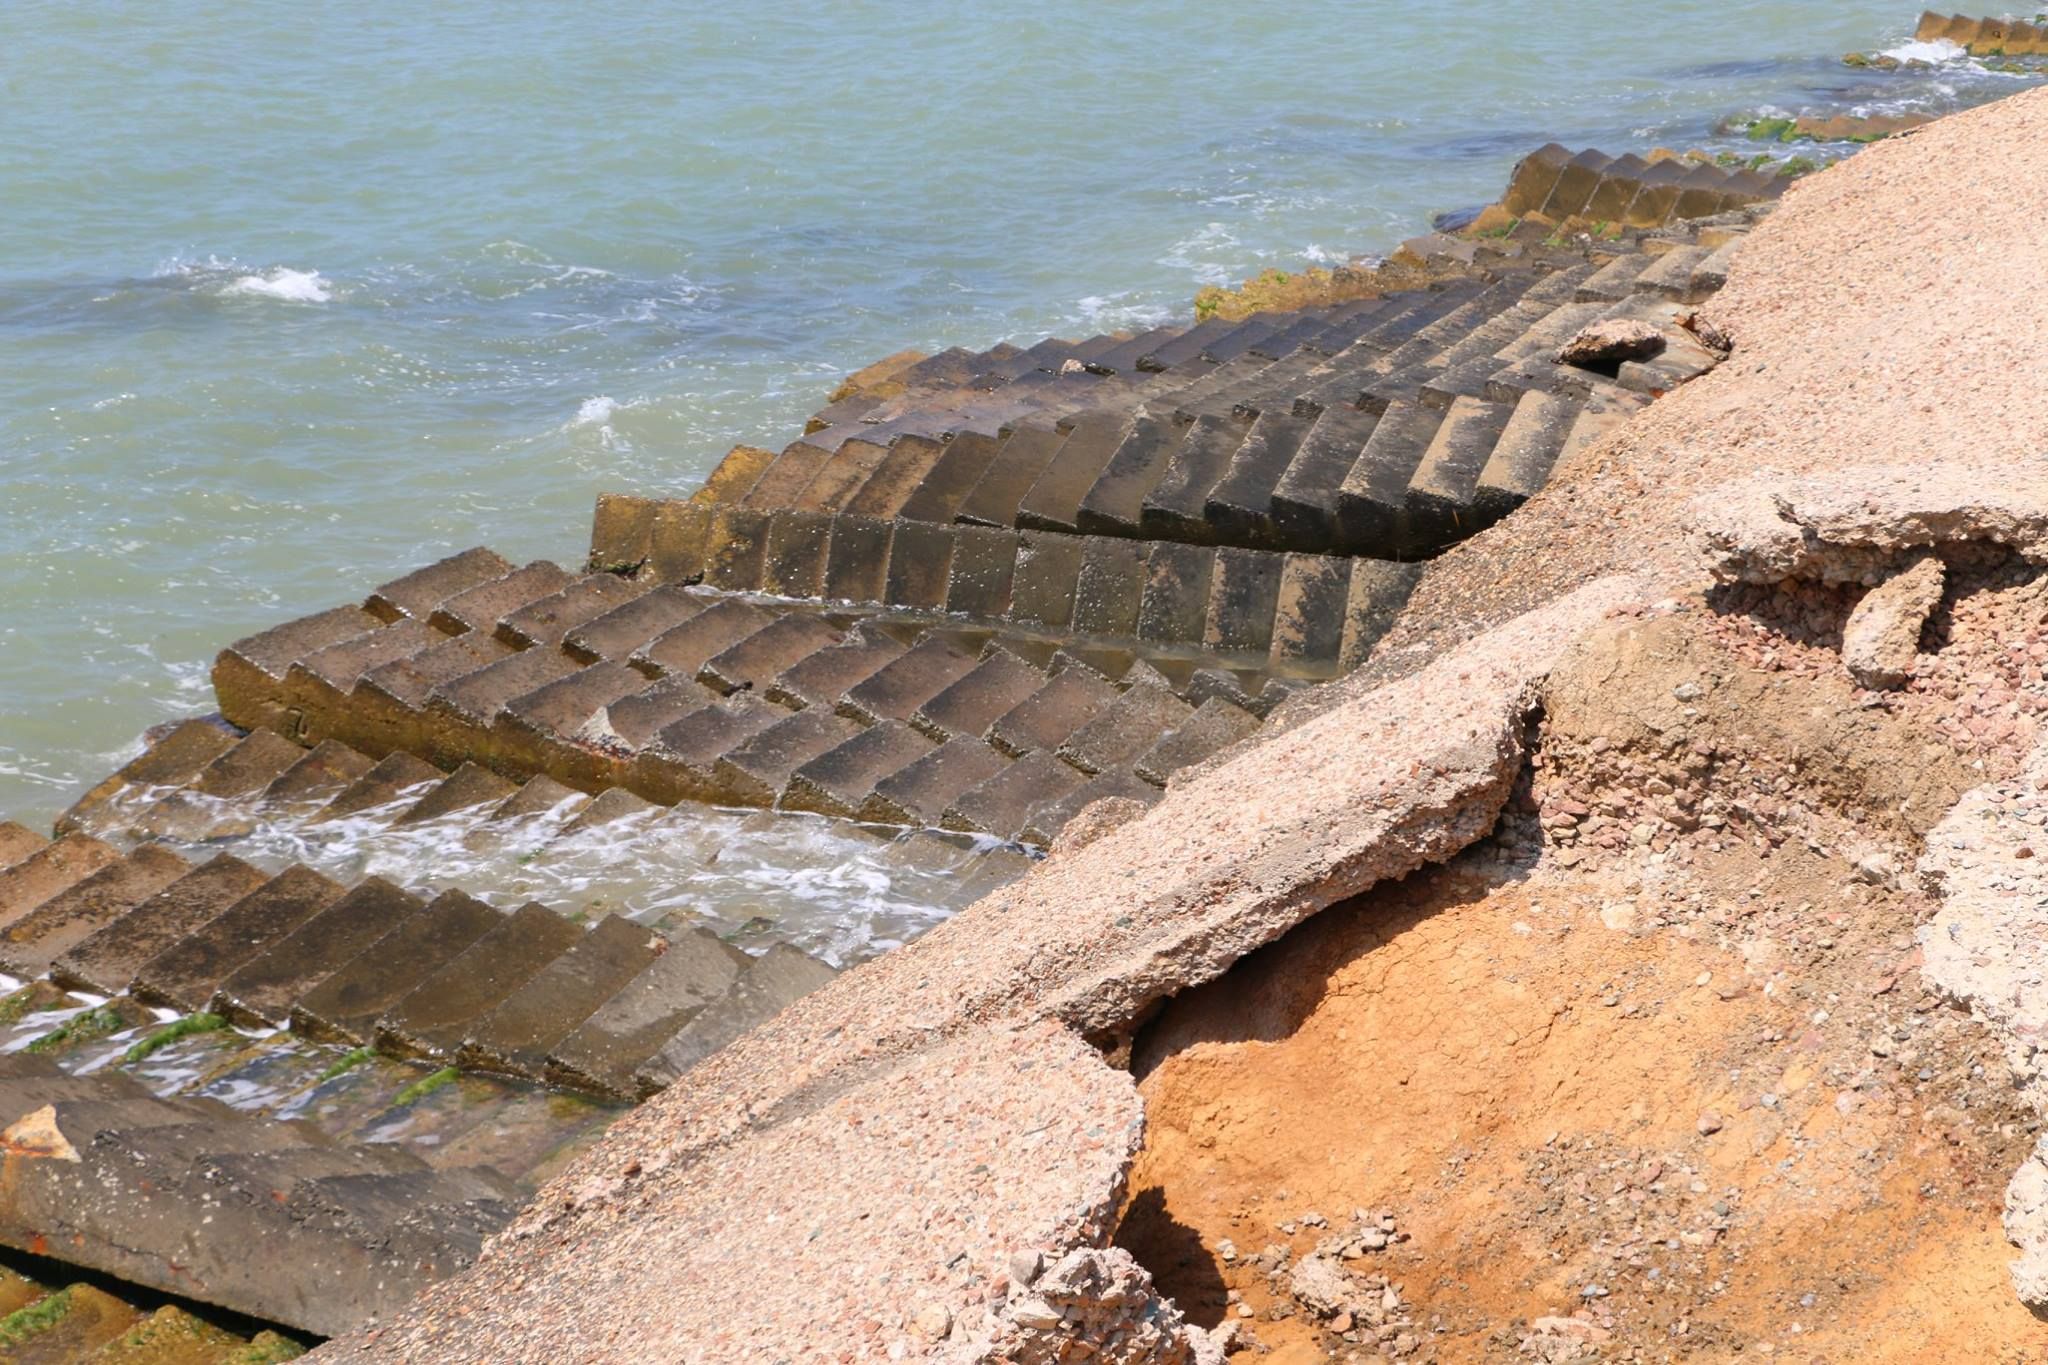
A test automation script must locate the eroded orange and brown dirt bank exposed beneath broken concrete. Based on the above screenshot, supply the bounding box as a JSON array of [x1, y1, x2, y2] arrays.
[[1118, 601, 2048, 1363]]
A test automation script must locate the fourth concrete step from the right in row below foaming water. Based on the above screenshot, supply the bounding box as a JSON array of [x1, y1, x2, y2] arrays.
[[375, 902, 584, 1058]]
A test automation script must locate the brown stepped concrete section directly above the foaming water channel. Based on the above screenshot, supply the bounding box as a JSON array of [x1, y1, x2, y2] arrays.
[[199, 540, 1351, 845]]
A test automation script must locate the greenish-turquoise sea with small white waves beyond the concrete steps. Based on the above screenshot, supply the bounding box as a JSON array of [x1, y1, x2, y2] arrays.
[[0, 0, 2007, 823]]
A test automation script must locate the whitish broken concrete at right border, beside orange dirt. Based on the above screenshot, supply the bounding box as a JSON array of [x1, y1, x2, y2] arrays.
[[1917, 741, 2048, 1312]]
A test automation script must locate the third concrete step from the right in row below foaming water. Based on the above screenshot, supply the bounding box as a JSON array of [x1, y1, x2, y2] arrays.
[[457, 915, 666, 1078]]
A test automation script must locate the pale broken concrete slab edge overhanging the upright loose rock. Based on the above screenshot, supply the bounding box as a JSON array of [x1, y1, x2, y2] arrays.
[[1688, 465, 2048, 587]]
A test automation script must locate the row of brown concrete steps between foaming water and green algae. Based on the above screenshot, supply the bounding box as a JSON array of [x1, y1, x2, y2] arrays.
[[0, 806, 834, 1099]]
